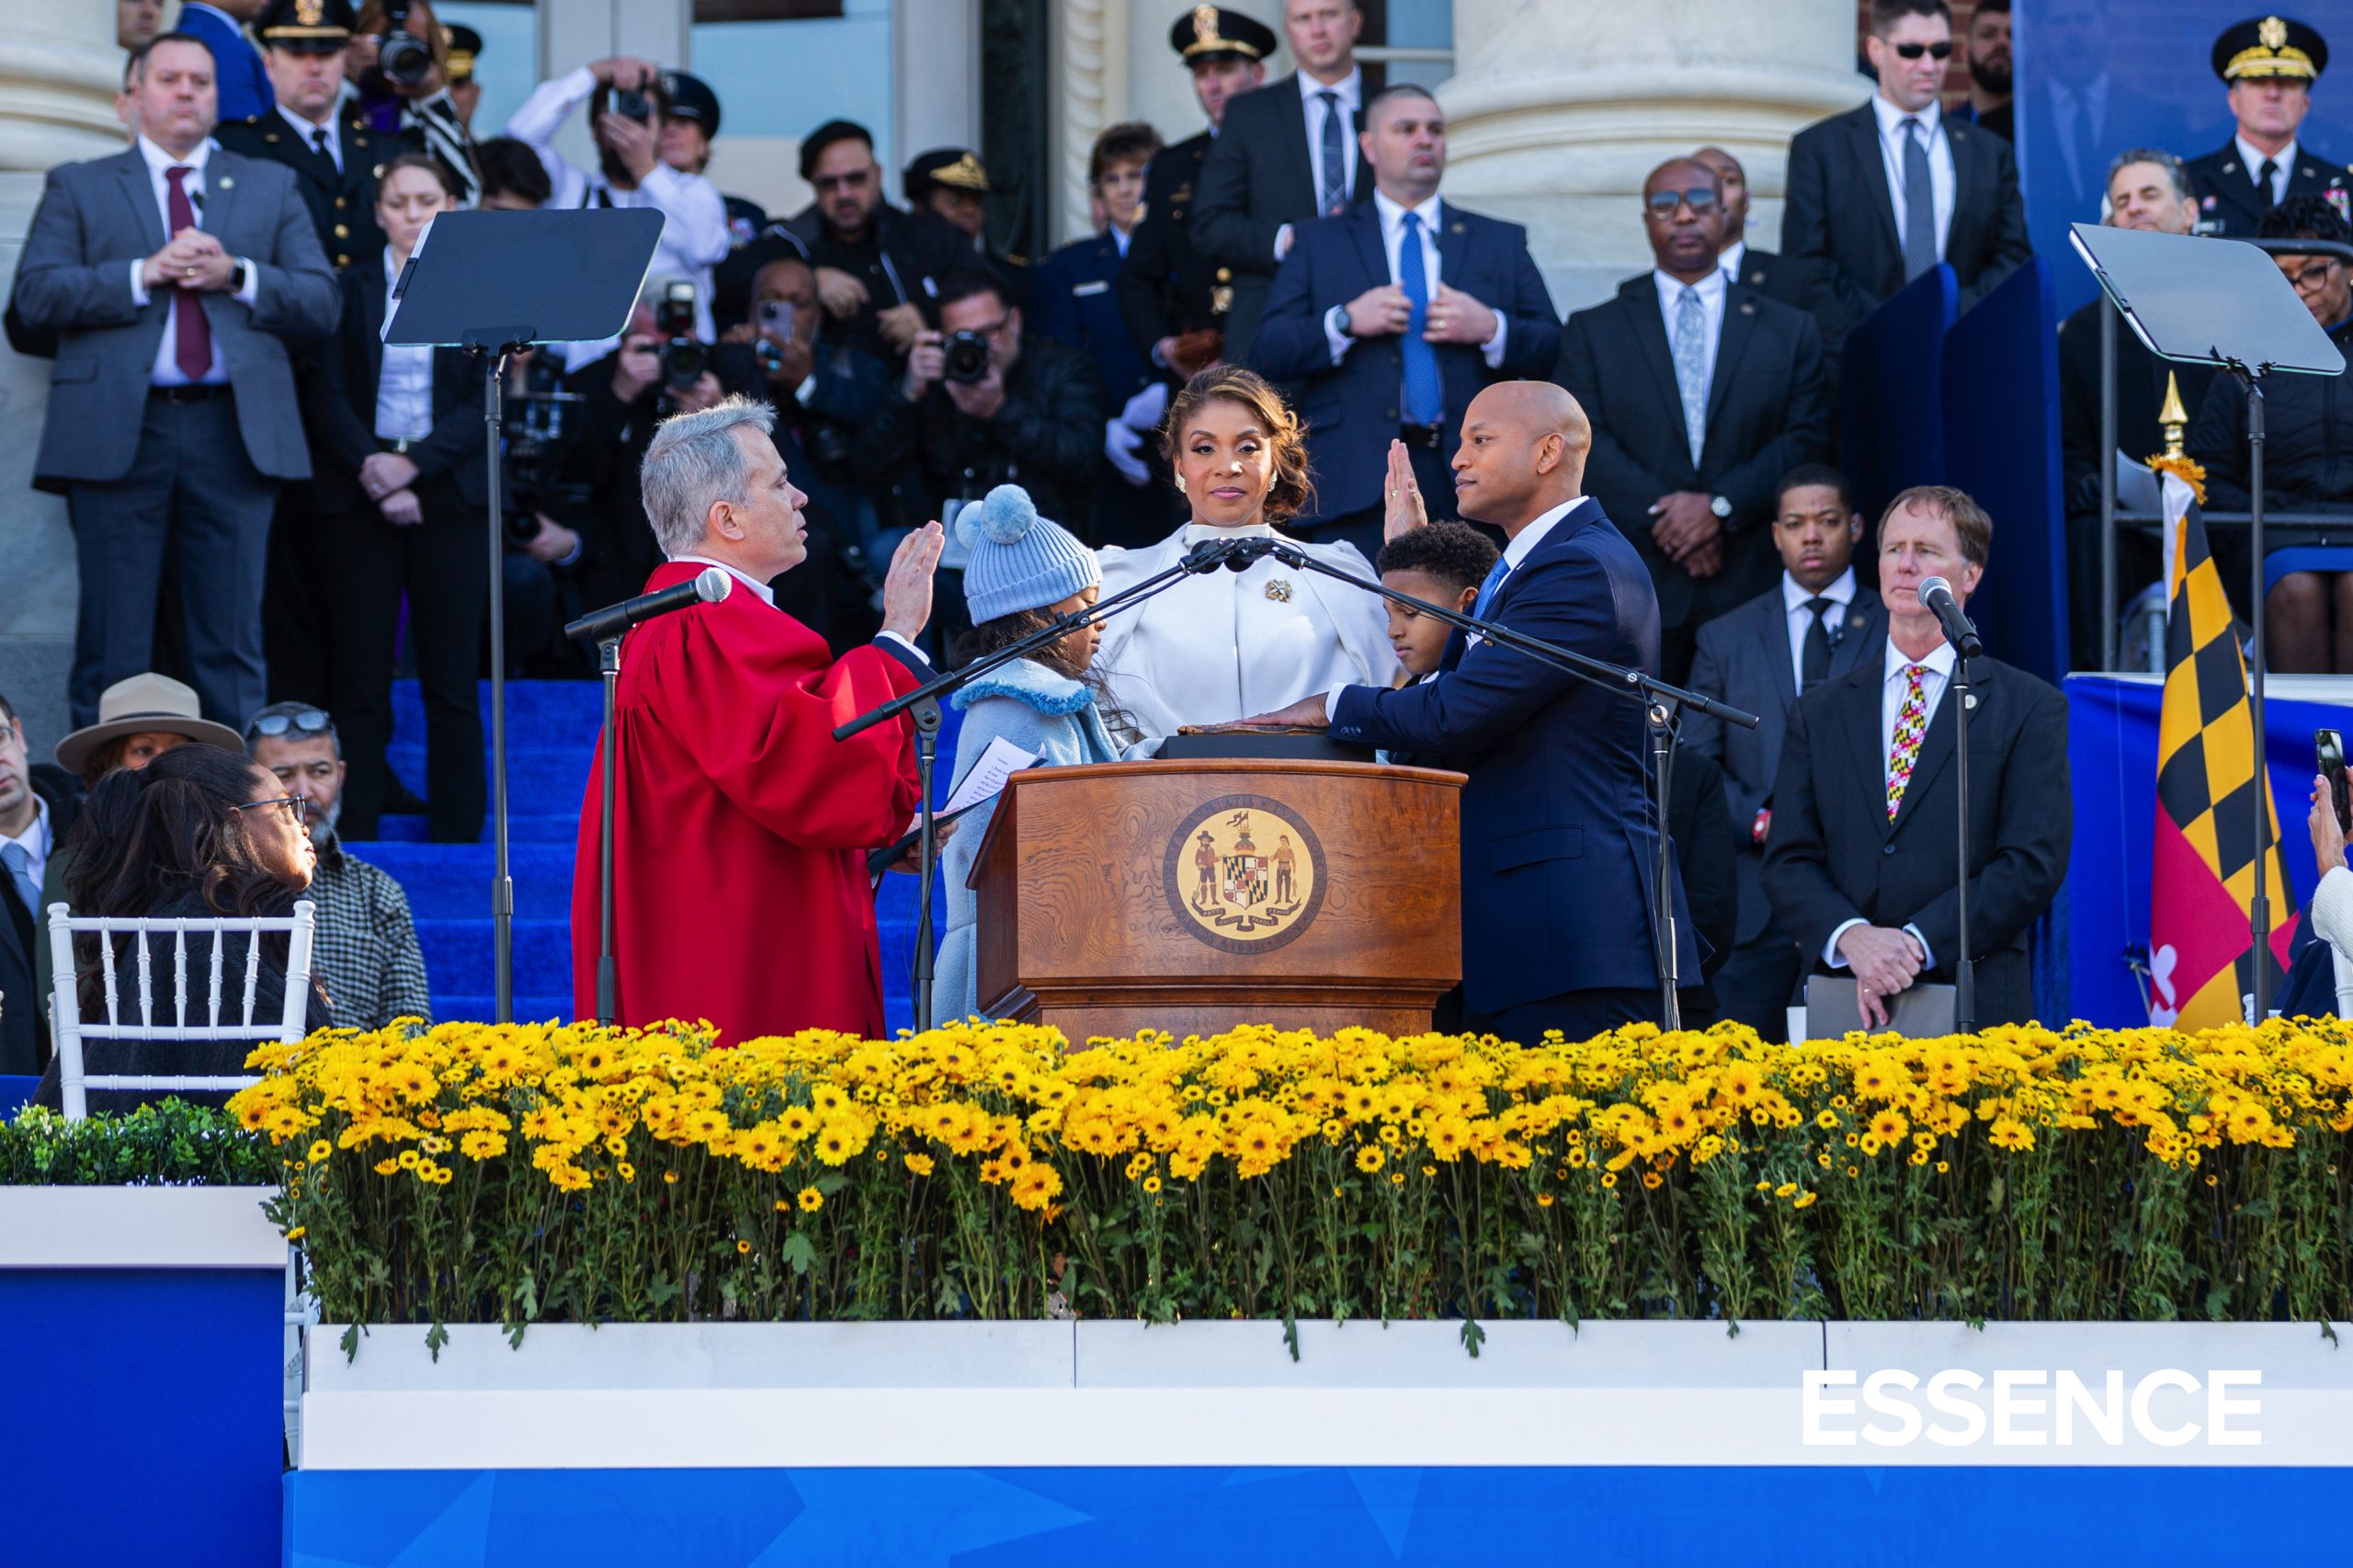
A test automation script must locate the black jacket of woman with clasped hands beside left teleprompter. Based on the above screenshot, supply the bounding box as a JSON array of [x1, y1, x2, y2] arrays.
[[303, 256, 489, 511]]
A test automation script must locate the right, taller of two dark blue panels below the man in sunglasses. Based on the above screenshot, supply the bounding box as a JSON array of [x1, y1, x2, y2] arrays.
[[1944, 256, 2068, 680]]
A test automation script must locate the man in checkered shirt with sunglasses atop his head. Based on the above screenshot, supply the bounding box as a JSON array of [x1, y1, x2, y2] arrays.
[[244, 701, 433, 1028]]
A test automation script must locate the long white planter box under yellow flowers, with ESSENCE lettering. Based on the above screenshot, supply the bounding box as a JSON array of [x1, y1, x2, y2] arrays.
[[303, 1321, 2353, 1469]]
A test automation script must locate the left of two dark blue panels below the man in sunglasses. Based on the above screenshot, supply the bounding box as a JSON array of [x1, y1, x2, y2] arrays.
[[1837, 266, 1958, 517]]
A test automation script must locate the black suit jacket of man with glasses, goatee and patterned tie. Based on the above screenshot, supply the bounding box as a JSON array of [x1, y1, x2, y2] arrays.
[[1553, 273, 1831, 629]]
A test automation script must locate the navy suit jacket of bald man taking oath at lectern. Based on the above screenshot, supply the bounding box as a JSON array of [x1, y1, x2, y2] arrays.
[[1332, 496, 1699, 1012]]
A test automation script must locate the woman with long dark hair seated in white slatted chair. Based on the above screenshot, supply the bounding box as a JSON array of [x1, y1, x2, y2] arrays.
[[33, 746, 335, 1111]]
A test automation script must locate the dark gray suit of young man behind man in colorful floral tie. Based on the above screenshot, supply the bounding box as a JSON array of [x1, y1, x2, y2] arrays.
[[1677, 584, 1887, 942]]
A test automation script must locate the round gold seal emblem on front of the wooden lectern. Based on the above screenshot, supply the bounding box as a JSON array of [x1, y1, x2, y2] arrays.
[[1163, 796, 1324, 953]]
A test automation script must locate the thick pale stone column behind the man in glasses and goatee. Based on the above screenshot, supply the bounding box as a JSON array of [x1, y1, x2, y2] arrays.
[[1440, 0, 1870, 311]]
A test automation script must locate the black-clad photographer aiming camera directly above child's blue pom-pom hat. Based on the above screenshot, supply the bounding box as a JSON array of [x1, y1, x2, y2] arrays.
[[854, 268, 1104, 636]]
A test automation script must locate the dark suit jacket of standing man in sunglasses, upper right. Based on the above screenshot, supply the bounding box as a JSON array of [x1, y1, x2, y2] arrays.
[[1781, 104, 2033, 332]]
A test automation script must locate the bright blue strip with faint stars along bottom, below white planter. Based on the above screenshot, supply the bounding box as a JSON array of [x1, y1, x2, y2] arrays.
[[285, 1467, 2353, 1568]]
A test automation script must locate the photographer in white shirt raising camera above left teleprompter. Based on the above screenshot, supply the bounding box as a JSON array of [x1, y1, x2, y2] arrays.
[[506, 54, 730, 348]]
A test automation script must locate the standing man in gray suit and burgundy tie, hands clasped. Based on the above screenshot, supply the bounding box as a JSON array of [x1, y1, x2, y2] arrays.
[[17, 33, 339, 725]]
